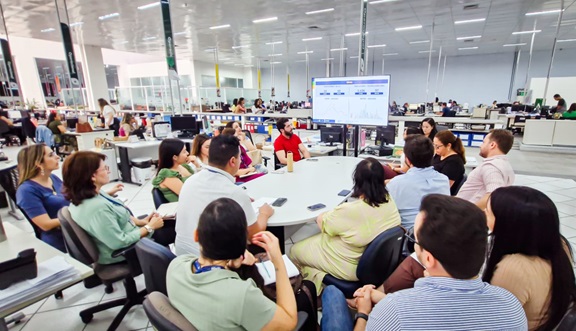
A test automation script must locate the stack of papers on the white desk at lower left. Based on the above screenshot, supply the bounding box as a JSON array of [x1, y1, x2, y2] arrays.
[[0, 256, 80, 310]]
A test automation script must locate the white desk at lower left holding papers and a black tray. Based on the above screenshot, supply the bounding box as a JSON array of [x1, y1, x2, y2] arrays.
[[0, 219, 94, 331]]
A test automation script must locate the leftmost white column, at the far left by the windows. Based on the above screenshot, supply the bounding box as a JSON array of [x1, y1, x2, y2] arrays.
[[12, 55, 46, 109]]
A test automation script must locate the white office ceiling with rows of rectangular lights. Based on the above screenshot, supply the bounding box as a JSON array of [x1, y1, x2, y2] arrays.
[[0, 0, 576, 67]]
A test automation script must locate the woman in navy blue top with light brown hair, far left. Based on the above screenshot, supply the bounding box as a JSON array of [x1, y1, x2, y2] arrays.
[[16, 144, 123, 252]]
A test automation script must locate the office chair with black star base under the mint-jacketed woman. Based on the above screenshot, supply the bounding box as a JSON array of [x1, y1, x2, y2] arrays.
[[58, 207, 146, 331]]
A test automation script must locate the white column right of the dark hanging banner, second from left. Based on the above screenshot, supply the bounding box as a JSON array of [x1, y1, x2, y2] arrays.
[[82, 45, 108, 110]]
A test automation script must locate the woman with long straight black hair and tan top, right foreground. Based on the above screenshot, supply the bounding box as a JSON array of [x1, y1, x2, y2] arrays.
[[482, 186, 576, 330]]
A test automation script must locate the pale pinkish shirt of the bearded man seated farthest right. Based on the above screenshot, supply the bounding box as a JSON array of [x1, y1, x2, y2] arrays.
[[457, 155, 515, 203]]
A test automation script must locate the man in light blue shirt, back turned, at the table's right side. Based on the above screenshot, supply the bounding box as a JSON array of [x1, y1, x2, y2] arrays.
[[386, 135, 450, 229]]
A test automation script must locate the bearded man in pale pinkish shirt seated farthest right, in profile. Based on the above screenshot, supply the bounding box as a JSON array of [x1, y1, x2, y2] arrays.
[[456, 129, 515, 209]]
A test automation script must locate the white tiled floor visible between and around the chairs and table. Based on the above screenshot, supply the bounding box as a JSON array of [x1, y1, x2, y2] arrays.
[[0, 140, 576, 331]]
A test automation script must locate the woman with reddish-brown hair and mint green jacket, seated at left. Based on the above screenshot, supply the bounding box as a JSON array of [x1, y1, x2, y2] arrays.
[[62, 151, 167, 264]]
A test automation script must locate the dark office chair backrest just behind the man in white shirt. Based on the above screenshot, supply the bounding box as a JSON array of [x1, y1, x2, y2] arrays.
[[136, 238, 176, 295]]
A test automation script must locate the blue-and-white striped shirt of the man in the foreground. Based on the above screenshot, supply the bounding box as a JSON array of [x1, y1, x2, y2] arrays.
[[366, 277, 528, 330]]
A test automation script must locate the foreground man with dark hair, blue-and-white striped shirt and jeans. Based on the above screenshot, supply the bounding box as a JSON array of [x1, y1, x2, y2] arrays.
[[322, 194, 528, 331]]
